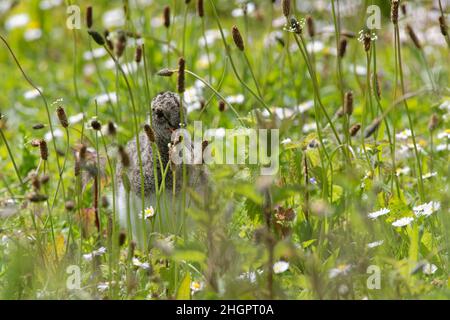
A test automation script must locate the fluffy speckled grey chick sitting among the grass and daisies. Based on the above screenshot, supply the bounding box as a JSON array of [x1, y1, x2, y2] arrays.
[[116, 92, 206, 246]]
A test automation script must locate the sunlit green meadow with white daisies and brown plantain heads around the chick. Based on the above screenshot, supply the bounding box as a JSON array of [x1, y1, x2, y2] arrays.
[[0, 0, 450, 300]]
